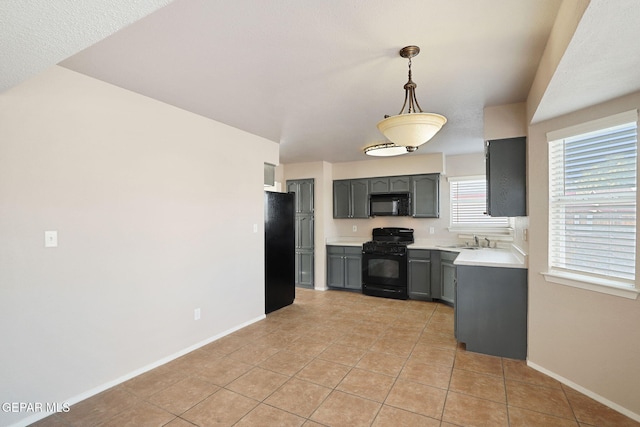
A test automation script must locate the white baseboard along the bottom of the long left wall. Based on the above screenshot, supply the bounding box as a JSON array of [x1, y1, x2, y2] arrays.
[[9, 314, 267, 427]]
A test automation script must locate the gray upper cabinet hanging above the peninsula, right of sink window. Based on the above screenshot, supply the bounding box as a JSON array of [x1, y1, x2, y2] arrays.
[[485, 137, 527, 217]]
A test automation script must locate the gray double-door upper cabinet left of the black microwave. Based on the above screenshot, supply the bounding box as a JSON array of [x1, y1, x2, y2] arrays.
[[333, 179, 369, 218]]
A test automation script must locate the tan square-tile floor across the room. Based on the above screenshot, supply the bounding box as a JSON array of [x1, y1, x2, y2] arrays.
[[36, 289, 640, 427]]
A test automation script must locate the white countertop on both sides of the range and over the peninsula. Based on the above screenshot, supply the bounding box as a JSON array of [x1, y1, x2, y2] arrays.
[[326, 237, 527, 268]]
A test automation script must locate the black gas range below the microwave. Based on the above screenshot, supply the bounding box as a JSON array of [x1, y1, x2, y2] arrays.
[[362, 227, 414, 299]]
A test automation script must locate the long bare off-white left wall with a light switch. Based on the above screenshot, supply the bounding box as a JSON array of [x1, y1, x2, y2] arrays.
[[0, 67, 278, 425]]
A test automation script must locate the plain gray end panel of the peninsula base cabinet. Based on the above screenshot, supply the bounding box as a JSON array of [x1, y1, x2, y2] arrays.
[[455, 265, 527, 359]]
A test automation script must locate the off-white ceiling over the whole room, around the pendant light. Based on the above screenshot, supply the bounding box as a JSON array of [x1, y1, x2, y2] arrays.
[[0, 0, 640, 163]]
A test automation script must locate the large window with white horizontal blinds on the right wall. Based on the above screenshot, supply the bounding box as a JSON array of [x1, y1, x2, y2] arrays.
[[549, 121, 637, 285]]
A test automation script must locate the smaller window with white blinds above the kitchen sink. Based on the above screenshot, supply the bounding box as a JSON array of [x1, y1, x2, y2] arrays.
[[449, 176, 509, 230]]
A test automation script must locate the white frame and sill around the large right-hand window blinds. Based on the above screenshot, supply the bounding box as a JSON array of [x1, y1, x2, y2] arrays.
[[542, 110, 640, 299]]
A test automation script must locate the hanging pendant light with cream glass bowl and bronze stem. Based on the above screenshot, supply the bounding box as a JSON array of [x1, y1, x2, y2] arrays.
[[378, 46, 447, 151]]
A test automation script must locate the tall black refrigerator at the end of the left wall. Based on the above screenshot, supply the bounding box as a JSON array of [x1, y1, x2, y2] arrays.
[[264, 191, 296, 314]]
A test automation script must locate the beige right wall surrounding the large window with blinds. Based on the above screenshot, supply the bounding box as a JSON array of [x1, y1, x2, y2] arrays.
[[528, 92, 640, 419]]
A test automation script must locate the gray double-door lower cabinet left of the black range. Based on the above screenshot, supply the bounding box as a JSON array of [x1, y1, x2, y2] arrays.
[[327, 245, 362, 290]]
